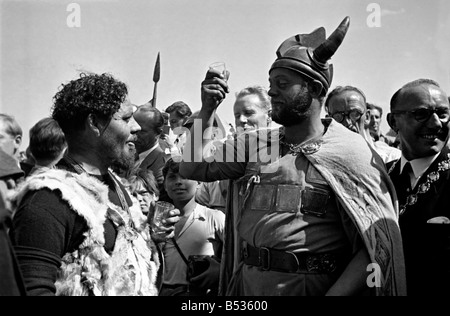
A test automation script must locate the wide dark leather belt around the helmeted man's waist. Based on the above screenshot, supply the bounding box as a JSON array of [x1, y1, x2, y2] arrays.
[[242, 244, 344, 273]]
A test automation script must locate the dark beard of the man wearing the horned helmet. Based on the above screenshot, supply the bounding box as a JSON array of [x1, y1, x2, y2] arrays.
[[272, 86, 312, 126]]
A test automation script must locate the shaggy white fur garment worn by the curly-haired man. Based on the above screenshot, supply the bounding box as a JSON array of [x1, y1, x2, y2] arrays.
[[12, 169, 159, 296]]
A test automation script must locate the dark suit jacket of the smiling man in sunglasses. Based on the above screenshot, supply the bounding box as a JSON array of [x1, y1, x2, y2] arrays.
[[388, 147, 450, 296]]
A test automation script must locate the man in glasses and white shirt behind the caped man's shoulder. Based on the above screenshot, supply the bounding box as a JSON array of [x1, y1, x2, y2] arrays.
[[325, 86, 401, 164]]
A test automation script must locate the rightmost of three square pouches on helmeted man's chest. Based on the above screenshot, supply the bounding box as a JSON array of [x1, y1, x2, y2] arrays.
[[301, 187, 330, 217]]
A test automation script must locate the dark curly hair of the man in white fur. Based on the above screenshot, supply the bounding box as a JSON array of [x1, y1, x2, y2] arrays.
[[52, 73, 128, 135]]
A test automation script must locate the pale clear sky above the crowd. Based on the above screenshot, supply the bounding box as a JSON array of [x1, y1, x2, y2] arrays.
[[0, 0, 450, 150]]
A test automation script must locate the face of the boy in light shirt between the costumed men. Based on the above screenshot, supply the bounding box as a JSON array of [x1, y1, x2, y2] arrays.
[[164, 170, 198, 202]]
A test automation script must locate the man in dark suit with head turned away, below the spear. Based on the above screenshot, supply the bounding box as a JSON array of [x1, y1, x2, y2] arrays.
[[131, 103, 170, 201]]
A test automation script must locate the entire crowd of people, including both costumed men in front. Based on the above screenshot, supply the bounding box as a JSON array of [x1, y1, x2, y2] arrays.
[[0, 17, 450, 296]]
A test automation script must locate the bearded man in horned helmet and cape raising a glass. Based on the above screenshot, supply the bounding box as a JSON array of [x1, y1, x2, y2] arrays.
[[180, 17, 405, 296]]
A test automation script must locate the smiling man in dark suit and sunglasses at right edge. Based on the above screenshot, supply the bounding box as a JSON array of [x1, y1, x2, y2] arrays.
[[388, 79, 450, 296]]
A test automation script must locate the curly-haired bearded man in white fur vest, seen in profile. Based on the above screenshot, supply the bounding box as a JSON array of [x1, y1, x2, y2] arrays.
[[10, 74, 176, 296]]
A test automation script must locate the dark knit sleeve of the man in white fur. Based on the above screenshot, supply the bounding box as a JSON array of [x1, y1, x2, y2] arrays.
[[10, 189, 87, 295]]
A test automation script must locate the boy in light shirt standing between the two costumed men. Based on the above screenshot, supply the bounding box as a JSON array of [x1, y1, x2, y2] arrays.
[[160, 159, 225, 296]]
